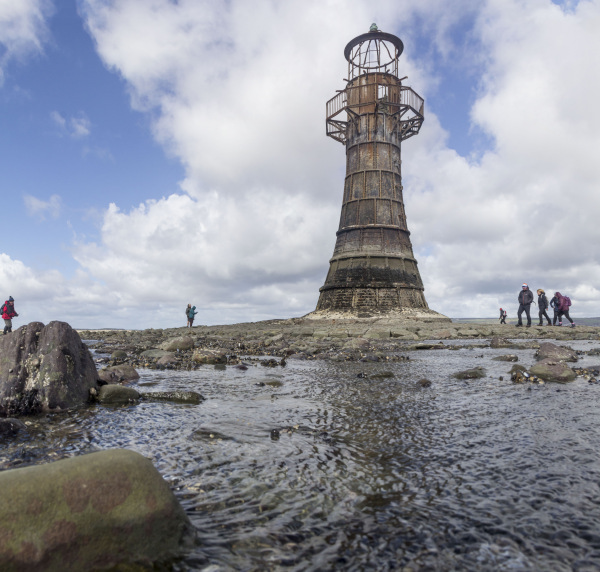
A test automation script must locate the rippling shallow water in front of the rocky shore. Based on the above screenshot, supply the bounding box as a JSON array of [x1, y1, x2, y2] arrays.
[[0, 342, 600, 572]]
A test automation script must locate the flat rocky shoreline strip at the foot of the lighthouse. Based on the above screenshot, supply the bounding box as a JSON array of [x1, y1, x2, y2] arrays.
[[78, 315, 600, 374]]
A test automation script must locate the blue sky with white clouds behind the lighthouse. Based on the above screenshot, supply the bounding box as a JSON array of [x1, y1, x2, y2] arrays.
[[0, 0, 600, 328]]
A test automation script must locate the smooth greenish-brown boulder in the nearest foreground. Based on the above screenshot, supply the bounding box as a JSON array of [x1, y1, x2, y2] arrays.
[[0, 449, 192, 571]]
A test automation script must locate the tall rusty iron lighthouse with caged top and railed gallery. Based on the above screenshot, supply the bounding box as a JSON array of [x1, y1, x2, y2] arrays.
[[317, 24, 433, 315]]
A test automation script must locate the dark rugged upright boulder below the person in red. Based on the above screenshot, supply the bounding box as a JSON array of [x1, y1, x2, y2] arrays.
[[0, 322, 98, 416]]
